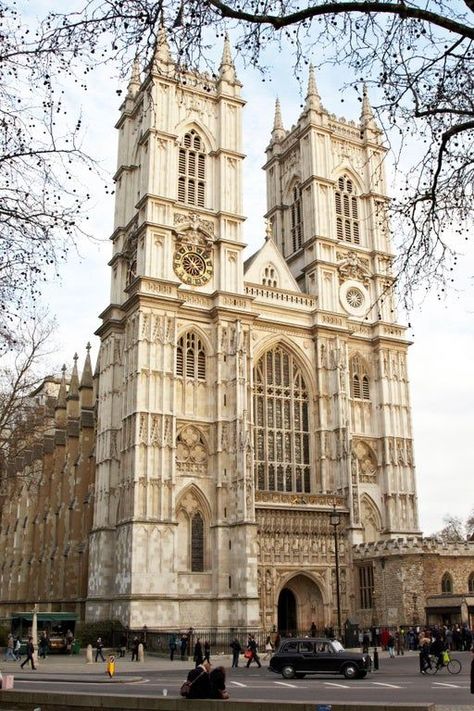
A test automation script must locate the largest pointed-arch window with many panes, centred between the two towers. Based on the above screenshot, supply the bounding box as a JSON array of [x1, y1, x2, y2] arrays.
[[254, 346, 311, 493]]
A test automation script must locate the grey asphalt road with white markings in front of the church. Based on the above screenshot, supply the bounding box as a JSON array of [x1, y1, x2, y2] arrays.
[[1, 652, 474, 711]]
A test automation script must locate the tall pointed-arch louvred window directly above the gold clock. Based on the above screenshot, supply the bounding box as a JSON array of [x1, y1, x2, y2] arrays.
[[178, 129, 206, 207]]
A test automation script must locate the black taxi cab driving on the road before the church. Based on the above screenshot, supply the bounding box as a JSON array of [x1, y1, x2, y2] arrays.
[[268, 637, 372, 679]]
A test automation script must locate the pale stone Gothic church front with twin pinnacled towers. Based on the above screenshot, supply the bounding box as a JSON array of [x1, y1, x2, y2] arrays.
[[87, 31, 418, 630]]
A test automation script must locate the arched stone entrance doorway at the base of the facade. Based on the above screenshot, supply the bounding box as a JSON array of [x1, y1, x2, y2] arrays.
[[277, 573, 326, 635]]
